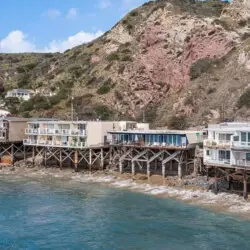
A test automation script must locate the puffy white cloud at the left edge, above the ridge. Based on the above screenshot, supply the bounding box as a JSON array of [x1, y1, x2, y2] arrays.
[[0, 30, 36, 53]]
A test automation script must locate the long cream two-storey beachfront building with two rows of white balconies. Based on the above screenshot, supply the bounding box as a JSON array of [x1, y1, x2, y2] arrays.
[[24, 120, 148, 148]]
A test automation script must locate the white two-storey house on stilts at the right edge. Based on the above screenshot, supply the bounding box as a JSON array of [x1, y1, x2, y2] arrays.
[[204, 123, 250, 168]]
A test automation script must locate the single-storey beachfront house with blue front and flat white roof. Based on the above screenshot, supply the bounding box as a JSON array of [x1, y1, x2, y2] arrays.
[[109, 129, 203, 149]]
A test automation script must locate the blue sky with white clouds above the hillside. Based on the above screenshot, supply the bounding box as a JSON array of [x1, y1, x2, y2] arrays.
[[0, 0, 147, 53]]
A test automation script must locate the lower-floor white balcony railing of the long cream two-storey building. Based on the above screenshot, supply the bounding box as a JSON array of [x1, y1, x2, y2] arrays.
[[23, 139, 85, 148]]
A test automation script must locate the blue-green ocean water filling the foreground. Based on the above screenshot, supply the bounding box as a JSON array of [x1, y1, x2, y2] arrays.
[[0, 175, 250, 250]]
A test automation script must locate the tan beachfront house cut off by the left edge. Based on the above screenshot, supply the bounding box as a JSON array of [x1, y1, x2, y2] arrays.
[[0, 117, 28, 142]]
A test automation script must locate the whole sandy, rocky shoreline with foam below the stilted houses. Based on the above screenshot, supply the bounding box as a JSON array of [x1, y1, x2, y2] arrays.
[[0, 163, 250, 220]]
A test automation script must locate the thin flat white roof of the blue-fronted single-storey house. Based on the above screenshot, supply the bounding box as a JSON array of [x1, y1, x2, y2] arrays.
[[109, 130, 202, 135]]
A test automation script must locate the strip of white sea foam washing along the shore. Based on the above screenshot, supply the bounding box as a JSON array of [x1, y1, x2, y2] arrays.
[[68, 174, 250, 213]]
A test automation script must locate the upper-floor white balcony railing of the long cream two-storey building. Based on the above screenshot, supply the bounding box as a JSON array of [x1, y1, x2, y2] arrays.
[[25, 128, 86, 137]]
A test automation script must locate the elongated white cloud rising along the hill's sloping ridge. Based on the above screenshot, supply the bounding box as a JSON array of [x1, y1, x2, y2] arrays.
[[45, 31, 103, 52]]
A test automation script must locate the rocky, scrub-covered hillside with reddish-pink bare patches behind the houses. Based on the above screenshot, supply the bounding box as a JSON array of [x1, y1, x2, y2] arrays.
[[0, 0, 250, 128]]
